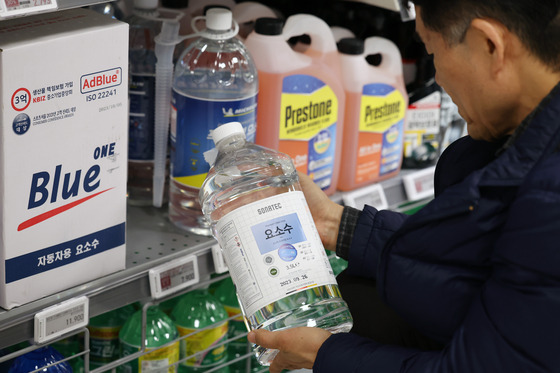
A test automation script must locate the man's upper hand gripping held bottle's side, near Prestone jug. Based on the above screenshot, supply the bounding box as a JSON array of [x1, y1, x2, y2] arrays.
[[298, 172, 344, 251]]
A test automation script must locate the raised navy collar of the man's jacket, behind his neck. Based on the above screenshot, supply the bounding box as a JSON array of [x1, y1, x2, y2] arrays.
[[478, 83, 560, 186]]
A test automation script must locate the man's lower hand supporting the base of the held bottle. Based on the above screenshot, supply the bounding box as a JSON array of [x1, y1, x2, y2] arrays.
[[247, 327, 331, 373]]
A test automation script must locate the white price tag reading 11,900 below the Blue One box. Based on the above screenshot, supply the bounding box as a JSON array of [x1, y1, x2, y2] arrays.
[[34, 296, 89, 343]]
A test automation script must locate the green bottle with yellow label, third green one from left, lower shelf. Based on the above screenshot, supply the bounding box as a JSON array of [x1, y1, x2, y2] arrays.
[[171, 289, 229, 373]]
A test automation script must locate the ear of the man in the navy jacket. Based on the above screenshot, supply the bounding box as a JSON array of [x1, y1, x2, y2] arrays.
[[469, 18, 510, 74]]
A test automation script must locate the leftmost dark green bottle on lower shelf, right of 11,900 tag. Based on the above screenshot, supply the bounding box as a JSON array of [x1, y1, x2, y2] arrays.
[[87, 304, 136, 369]]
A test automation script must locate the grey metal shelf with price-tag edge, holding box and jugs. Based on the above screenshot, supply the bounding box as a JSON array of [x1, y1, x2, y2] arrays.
[[0, 166, 434, 348]]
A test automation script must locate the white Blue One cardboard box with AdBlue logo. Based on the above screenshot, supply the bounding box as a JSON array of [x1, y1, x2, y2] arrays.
[[0, 9, 128, 309]]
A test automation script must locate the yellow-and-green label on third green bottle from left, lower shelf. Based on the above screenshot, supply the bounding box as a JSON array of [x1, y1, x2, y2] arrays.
[[177, 322, 228, 368]]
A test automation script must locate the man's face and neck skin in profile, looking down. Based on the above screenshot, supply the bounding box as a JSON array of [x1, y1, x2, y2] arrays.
[[416, 7, 516, 141]]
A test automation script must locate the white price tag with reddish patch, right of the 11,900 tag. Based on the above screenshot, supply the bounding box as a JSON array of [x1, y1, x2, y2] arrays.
[[149, 255, 200, 299]]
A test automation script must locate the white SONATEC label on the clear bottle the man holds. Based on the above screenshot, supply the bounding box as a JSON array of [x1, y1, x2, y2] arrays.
[[216, 191, 336, 315]]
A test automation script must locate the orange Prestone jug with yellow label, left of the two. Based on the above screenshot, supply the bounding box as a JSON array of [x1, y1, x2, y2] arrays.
[[245, 14, 345, 195]]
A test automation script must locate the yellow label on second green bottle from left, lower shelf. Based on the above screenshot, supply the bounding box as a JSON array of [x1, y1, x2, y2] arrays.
[[120, 340, 179, 373]]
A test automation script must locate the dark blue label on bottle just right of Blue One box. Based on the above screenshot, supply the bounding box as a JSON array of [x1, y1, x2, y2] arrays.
[[128, 74, 156, 161]]
